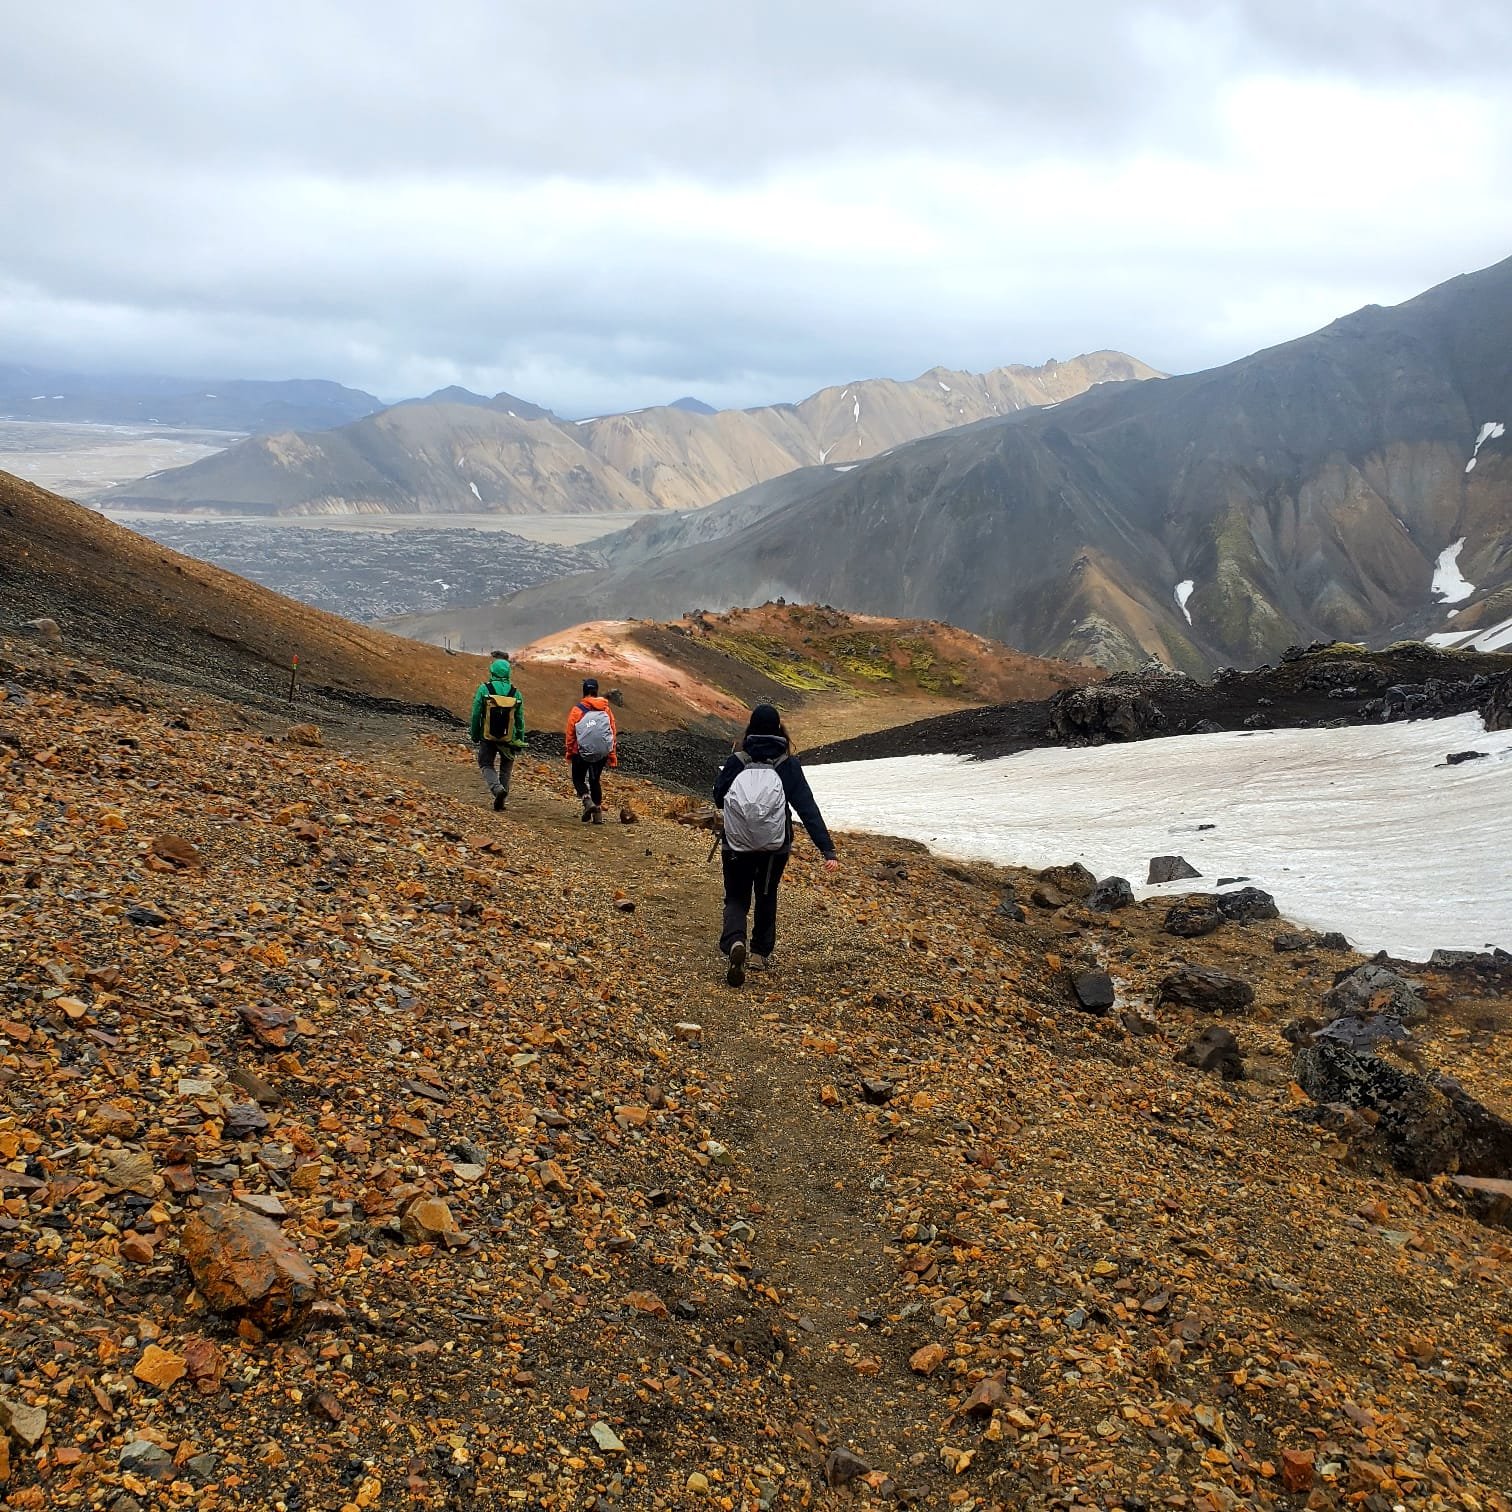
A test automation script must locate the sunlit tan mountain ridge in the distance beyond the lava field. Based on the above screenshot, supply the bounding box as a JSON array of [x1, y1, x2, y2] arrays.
[[101, 352, 1157, 514]]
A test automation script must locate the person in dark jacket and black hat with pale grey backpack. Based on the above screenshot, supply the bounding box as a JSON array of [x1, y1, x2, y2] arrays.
[[714, 703, 839, 987]]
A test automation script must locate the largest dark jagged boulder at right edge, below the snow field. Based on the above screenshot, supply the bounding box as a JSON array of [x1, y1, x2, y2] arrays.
[[1293, 1039, 1512, 1181]]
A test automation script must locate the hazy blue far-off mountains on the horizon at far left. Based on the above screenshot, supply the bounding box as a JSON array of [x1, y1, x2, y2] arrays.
[[0, 363, 383, 431]]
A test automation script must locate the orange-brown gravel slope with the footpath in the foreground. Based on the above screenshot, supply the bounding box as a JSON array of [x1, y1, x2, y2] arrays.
[[0, 646, 1512, 1512]]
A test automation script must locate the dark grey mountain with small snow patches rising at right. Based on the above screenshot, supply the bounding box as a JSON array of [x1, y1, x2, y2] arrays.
[[396, 260, 1512, 673]]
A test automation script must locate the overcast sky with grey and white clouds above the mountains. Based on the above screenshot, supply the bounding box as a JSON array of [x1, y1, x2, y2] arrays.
[[0, 0, 1512, 414]]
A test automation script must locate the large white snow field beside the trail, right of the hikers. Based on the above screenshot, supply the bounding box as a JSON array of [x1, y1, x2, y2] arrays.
[[809, 714, 1512, 960]]
